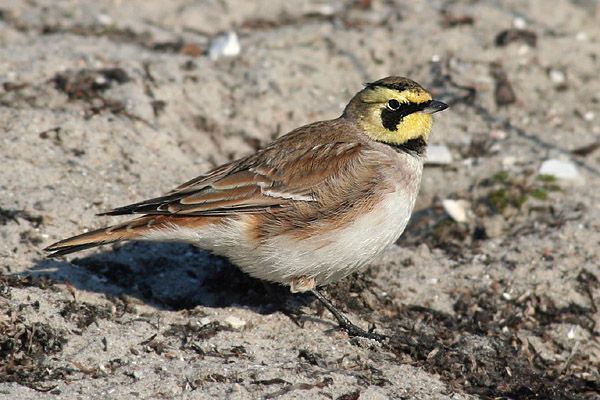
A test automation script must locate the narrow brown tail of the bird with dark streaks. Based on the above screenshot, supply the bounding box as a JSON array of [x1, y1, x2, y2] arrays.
[[44, 216, 167, 257]]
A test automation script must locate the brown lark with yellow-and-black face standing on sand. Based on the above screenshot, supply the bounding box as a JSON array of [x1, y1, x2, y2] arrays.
[[45, 76, 448, 339]]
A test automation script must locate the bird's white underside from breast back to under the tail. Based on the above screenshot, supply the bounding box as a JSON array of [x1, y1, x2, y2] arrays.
[[146, 184, 416, 285]]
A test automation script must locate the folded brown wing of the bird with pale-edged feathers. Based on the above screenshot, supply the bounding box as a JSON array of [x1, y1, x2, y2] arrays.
[[101, 141, 363, 216]]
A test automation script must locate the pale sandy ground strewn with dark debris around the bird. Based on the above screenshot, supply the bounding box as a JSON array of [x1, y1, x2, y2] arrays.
[[0, 0, 600, 400]]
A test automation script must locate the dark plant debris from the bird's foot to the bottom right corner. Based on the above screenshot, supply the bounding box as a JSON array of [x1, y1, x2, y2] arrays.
[[329, 271, 600, 399]]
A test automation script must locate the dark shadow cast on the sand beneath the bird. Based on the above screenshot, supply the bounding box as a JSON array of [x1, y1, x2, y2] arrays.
[[27, 242, 309, 314]]
